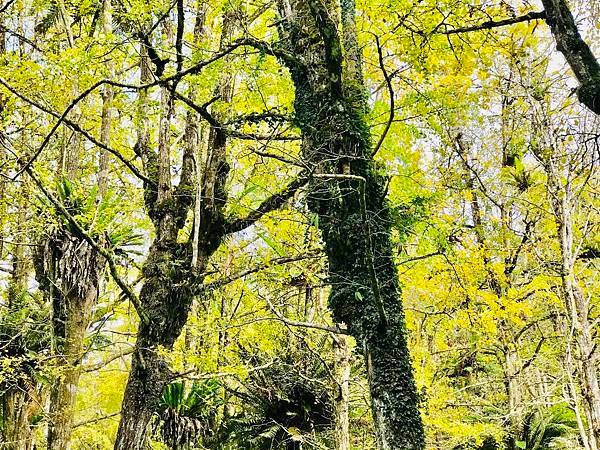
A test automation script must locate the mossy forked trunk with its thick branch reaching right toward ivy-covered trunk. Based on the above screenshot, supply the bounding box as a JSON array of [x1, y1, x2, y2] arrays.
[[115, 2, 304, 444]]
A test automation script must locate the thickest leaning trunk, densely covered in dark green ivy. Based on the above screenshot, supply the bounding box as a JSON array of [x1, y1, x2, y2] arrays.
[[280, 0, 424, 450]]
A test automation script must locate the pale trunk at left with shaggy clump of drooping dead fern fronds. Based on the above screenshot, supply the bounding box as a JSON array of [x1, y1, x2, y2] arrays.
[[36, 6, 105, 440]]
